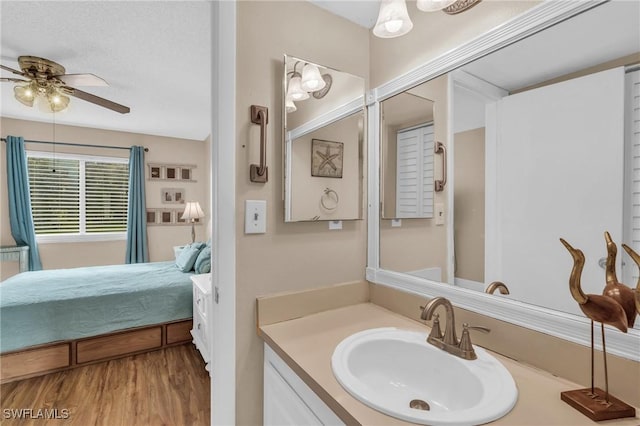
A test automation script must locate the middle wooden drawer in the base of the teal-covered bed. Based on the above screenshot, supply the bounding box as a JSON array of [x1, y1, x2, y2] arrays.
[[77, 326, 162, 364]]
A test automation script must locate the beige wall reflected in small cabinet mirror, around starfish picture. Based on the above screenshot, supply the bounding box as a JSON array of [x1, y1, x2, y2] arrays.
[[291, 114, 365, 221]]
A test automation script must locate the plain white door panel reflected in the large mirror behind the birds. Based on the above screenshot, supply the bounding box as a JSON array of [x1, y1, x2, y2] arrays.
[[485, 68, 624, 315]]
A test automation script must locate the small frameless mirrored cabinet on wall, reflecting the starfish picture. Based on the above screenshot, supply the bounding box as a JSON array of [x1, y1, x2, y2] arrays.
[[282, 55, 365, 222]]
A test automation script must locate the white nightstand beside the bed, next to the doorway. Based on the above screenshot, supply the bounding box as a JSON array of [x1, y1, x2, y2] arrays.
[[191, 274, 212, 374]]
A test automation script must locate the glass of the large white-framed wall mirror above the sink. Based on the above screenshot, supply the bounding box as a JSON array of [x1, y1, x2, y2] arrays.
[[372, 2, 640, 359]]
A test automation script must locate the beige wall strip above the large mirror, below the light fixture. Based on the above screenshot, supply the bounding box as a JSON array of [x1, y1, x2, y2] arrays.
[[370, 0, 541, 87]]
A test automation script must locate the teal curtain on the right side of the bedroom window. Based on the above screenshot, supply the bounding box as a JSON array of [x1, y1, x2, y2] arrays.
[[125, 146, 149, 263]]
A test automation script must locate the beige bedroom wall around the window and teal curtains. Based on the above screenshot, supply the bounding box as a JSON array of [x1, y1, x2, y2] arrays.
[[0, 118, 211, 279]]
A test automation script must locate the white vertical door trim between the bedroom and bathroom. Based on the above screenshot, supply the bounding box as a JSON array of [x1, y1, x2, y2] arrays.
[[207, 0, 237, 425]]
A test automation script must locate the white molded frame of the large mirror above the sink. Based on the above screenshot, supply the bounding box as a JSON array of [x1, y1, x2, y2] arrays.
[[366, 0, 640, 361]]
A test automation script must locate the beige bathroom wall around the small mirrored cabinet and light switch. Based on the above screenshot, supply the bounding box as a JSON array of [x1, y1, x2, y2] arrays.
[[236, 1, 369, 425]]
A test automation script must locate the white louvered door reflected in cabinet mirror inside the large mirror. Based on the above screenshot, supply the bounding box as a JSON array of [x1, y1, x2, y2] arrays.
[[396, 125, 434, 218]]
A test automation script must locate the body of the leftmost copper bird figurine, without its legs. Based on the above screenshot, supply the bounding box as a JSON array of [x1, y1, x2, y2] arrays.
[[560, 238, 628, 333]]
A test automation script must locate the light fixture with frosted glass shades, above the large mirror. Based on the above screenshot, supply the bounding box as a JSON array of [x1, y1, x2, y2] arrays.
[[373, 0, 481, 38]]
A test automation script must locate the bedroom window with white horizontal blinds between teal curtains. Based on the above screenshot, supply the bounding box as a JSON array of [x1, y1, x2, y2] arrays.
[[27, 151, 129, 241]]
